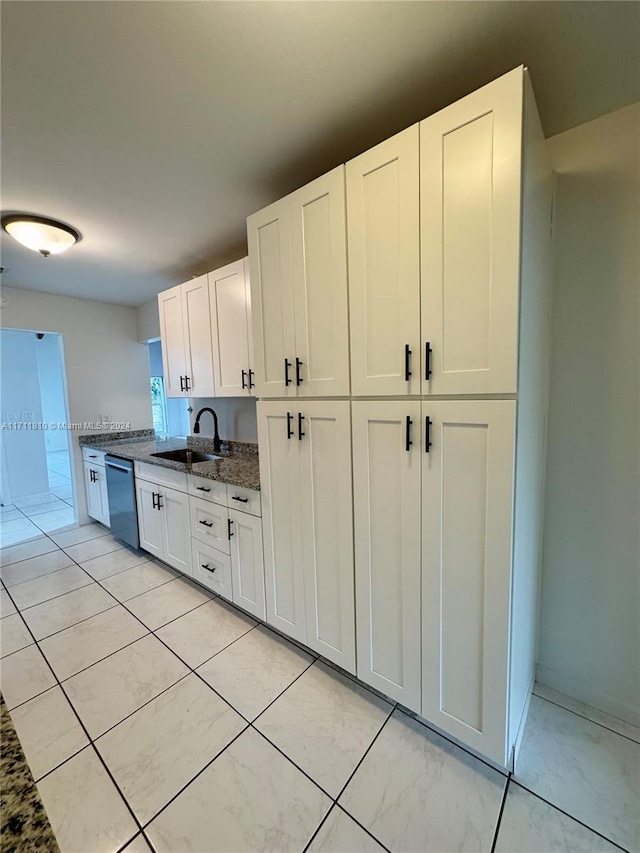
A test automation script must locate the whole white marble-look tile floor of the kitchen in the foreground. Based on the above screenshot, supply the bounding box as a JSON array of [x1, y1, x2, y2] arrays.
[[0, 524, 640, 853]]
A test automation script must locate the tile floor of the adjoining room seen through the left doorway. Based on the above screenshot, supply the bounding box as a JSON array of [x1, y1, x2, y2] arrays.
[[0, 450, 76, 548]]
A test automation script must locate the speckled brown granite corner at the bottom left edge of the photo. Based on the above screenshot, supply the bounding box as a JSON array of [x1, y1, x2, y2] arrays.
[[0, 694, 60, 853]]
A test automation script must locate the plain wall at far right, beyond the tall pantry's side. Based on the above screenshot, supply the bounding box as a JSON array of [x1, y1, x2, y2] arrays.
[[538, 103, 640, 724]]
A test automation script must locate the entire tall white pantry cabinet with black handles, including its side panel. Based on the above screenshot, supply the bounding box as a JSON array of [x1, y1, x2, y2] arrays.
[[248, 67, 551, 766]]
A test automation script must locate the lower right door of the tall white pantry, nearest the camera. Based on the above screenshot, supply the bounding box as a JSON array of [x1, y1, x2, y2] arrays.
[[422, 400, 516, 765]]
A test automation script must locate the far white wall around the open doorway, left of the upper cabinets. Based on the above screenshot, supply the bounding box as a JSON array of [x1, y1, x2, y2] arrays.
[[0, 290, 153, 521]]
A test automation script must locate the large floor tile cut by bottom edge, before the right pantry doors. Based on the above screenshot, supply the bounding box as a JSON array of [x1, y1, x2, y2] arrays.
[[340, 710, 506, 853]]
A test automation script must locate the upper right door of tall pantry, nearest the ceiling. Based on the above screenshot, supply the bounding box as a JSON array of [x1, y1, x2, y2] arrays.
[[420, 68, 523, 394]]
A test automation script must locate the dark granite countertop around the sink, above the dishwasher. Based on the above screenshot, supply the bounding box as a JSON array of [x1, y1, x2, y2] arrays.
[[79, 430, 260, 491]]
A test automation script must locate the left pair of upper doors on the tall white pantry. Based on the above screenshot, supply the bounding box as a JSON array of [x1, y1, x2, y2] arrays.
[[247, 166, 349, 397]]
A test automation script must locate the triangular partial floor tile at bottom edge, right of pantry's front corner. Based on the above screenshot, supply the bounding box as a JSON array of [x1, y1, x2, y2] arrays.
[[495, 782, 620, 853]]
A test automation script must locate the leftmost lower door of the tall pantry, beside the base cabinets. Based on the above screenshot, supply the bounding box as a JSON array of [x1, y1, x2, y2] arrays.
[[258, 401, 306, 643]]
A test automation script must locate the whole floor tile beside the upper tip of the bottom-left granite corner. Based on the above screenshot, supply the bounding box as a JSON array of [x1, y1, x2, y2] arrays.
[[11, 687, 89, 780]]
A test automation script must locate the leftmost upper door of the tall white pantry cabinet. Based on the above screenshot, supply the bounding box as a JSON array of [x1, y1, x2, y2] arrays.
[[247, 198, 296, 397]]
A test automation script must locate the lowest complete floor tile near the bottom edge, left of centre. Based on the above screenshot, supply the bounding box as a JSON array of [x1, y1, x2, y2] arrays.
[[96, 675, 247, 824]]
